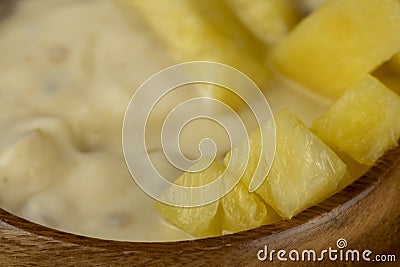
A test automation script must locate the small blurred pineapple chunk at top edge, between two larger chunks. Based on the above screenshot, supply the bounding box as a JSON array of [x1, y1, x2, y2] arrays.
[[226, 0, 300, 44]]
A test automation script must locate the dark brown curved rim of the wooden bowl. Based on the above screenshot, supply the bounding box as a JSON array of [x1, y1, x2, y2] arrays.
[[0, 144, 400, 252]]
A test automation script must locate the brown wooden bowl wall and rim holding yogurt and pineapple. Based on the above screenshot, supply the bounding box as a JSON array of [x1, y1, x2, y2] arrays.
[[0, 148, 400, 266]]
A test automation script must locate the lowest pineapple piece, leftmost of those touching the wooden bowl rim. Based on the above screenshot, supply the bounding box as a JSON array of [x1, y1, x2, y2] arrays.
[[156, 161, 279, 237]]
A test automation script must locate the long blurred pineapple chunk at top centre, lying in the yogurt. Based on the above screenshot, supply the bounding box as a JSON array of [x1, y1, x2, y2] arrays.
[[125, 0, 270, 85]]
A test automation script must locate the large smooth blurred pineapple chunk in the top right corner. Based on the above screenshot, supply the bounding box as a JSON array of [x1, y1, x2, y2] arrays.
[[271, 0, 400, 98]]
